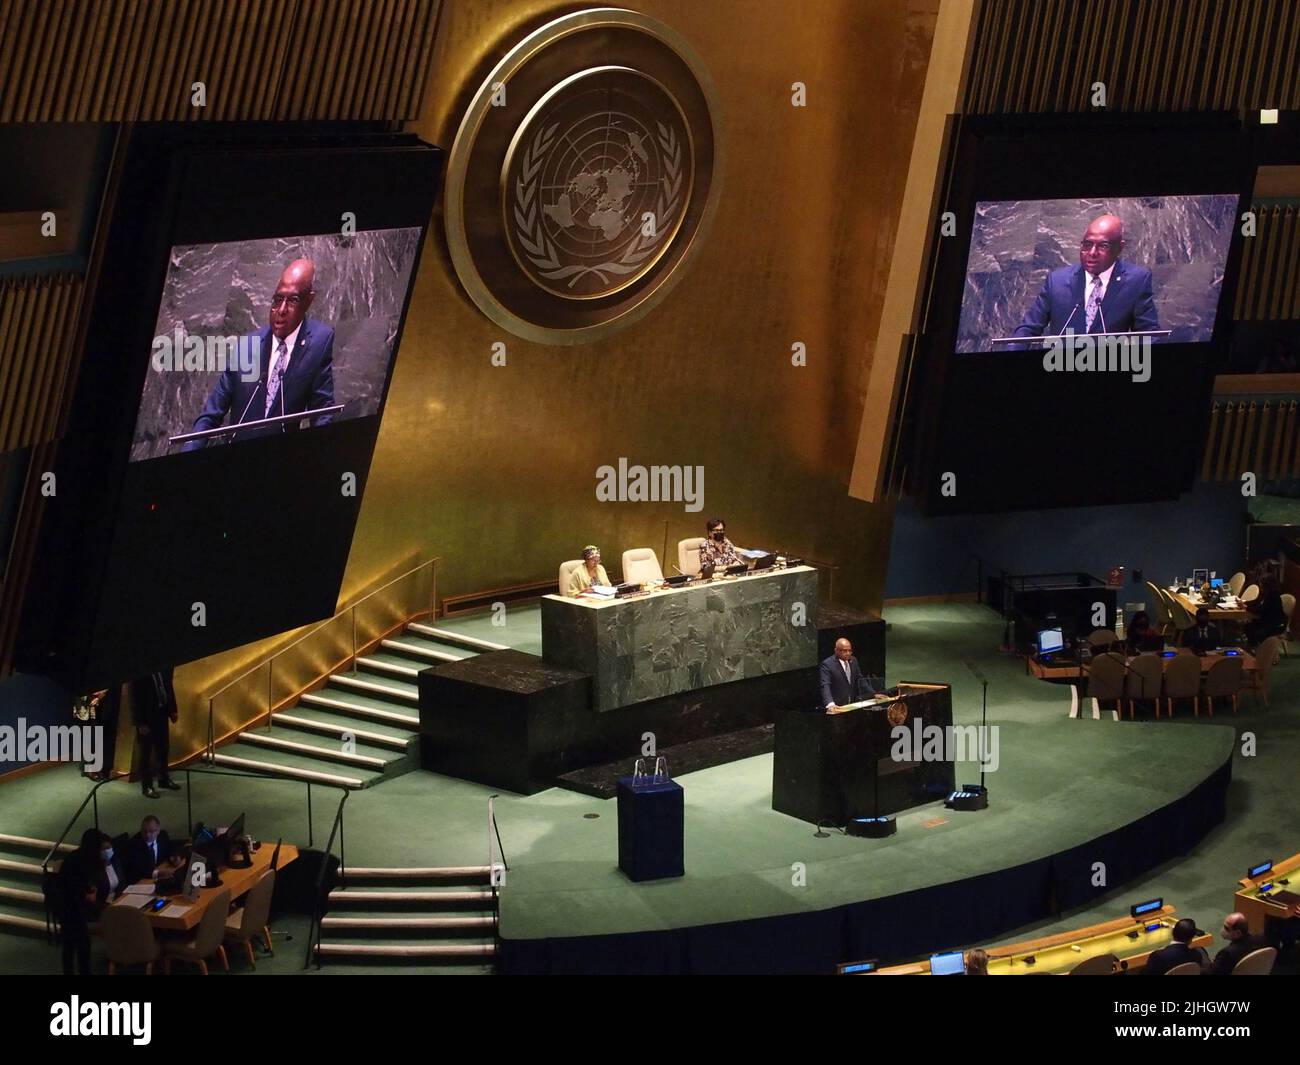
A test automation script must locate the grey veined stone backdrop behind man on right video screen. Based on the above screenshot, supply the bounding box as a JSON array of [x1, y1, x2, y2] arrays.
[[957, 194, 1236, 351]]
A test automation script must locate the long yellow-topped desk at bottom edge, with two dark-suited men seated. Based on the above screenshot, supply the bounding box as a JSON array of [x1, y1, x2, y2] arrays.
[[861, 906, 1214, 977]]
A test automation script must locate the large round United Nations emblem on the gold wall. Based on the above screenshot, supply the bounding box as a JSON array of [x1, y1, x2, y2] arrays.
[[446, 8, 720, 343]]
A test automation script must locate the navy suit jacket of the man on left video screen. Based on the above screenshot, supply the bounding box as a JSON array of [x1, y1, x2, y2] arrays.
[[182, 317, 334, 451]]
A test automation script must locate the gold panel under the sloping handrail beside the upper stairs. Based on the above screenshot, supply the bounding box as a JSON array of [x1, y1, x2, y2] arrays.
[[205, 558, 438, 762]]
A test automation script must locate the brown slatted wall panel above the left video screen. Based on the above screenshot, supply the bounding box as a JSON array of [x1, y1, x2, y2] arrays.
[[0, 0, 439, 122]]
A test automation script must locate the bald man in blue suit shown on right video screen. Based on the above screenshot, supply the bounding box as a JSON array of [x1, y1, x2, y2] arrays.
[[1015, 215, 1160, 337]]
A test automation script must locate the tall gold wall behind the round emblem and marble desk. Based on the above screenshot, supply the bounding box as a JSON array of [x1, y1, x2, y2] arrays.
[[345, 0, 937, 621]]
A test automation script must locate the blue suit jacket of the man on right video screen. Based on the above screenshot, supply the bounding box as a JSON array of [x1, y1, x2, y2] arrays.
[[1014, 259, 1160, 337]]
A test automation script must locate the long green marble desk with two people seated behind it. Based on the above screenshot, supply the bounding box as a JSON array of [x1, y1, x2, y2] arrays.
[[542, 566, 818, 711]]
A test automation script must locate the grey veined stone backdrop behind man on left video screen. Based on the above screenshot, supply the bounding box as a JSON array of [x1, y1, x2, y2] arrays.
[[131, 229, 420, 462]]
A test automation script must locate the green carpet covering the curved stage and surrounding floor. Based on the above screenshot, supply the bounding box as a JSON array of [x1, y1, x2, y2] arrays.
[[0, 605, 1300, 973]]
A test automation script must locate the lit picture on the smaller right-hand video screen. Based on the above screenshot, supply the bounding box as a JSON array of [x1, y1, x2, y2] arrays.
[[957, 190, 1239, 352]]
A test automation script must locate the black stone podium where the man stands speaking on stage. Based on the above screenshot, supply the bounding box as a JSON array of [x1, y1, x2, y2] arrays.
[[772, 684, 956, 824]]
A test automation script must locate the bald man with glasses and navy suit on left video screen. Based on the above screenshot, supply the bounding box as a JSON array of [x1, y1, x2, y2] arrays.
[[182, 259, 334, 451]]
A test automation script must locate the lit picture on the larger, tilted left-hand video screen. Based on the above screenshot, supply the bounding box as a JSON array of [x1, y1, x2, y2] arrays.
[[130, 226, 420, 462]]
